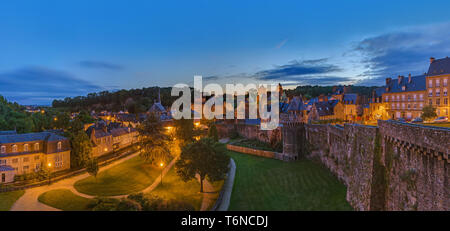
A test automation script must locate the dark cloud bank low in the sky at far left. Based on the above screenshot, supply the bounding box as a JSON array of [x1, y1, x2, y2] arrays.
[[0, 67, 102, 104]]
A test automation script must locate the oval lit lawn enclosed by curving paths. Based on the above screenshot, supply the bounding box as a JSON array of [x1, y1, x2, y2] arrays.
[[74, 156, 161, 196]]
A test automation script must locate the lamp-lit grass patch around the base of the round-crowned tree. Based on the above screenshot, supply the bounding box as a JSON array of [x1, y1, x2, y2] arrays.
[[150, 167, 203, 210]]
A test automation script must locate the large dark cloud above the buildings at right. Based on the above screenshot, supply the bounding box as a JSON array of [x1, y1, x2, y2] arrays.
[[352, 23, 450, 85]]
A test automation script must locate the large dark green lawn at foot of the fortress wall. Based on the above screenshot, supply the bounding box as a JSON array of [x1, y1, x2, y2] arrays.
[[229, 151, 352, 211]]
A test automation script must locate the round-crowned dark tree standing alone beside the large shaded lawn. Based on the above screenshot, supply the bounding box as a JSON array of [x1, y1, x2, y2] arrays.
[[175, 138, 230, 192]]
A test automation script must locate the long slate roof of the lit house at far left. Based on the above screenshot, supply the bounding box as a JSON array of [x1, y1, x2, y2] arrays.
[[0, 131, 67, 144]]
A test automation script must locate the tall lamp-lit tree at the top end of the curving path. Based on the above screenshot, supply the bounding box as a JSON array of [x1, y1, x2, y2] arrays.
[[137, 113, 171, 164]]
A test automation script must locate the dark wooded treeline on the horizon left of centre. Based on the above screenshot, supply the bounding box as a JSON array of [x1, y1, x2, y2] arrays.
[[52, 87, 178, 113]]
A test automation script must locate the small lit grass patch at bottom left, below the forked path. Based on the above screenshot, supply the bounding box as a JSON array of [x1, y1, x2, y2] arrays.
[[38, 189, 95, 211]]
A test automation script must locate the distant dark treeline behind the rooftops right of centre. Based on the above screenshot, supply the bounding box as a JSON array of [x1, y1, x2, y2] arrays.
[[286, 85, 378, 99]]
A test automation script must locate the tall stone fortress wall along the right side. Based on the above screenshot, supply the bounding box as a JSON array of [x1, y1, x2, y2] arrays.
[[283, 121, 450, 211]]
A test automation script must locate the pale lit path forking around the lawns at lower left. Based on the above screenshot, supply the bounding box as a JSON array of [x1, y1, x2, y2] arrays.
[[11, 152, 139, 211]]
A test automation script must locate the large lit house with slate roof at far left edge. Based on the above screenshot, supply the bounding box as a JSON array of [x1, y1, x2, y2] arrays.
[[0, 131, 70, 183]]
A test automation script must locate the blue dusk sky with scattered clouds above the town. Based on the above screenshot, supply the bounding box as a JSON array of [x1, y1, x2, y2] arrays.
[[0, 0, 450, 105]]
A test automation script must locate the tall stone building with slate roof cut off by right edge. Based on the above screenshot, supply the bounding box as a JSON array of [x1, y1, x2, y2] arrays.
[[426, 57, 450, 117]]
